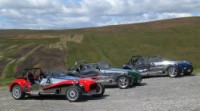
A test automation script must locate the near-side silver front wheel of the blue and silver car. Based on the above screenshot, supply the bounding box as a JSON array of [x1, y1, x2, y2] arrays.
[[167, 66, 180, 78]]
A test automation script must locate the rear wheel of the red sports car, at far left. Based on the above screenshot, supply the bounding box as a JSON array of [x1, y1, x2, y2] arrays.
[[11, 85, 25, 100]]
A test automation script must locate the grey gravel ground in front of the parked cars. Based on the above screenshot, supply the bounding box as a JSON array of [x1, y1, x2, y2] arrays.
[[0, 74, 200, 111]]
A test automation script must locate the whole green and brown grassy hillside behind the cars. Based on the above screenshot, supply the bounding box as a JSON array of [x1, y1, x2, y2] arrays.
[[0, 17, 200, 84]]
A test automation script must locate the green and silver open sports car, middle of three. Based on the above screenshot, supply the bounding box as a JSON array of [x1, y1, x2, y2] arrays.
[[70, 61, 142, 89]]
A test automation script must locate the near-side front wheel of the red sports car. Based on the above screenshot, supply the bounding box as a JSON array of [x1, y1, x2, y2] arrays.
[[65, 86, 82, 102]]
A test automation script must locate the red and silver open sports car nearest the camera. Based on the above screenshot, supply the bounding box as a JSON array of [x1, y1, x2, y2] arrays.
[[9, 68, 105, 102]]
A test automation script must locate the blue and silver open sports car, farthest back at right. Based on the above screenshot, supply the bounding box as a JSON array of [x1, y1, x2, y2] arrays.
[[123, 56, 193, 78]]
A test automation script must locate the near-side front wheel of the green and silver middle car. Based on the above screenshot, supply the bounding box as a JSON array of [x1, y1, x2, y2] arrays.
[[117, 76, 130, 89]]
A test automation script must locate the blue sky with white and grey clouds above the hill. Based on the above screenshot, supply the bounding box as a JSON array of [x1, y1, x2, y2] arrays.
[[0, 0, 200, 30]]
